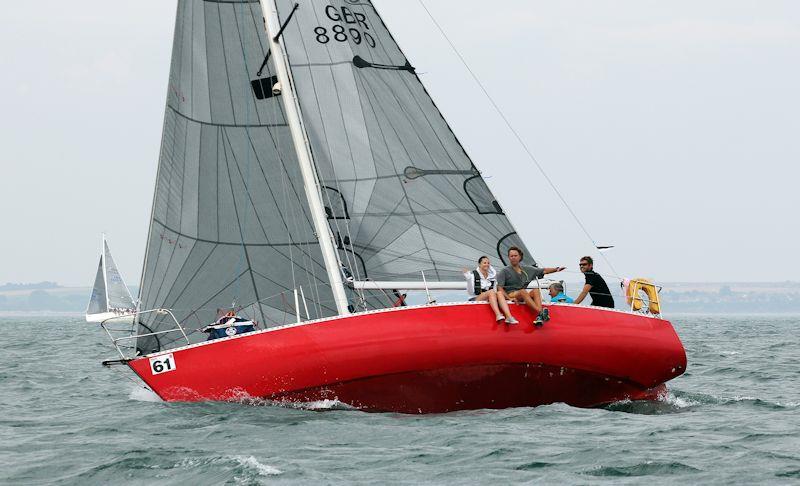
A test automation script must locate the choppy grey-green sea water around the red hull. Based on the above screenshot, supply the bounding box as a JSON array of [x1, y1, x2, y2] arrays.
[[0, 315, 800, 485]]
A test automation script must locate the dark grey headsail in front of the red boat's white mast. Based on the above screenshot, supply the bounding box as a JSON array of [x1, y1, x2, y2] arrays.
[[137, 0, 337, 353]]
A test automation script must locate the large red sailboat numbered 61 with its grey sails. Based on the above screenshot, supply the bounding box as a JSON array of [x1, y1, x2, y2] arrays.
[[92, 0, 686, 413]]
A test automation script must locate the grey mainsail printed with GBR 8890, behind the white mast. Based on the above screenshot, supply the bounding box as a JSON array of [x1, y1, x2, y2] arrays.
[[277, 0, 534, 307]]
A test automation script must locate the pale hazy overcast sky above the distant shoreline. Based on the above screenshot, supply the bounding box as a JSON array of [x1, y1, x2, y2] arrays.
[[0, 0, 800, 285]]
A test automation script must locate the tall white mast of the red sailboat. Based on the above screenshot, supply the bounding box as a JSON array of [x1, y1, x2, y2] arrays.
[[260, 0, 350, 315]]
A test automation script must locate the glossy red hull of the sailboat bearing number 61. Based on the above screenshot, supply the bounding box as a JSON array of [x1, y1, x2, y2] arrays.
[[129, 303, 686, 413]]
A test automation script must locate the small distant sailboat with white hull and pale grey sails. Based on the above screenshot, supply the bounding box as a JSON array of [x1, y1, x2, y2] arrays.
[[86, 235, 136, 323]]
